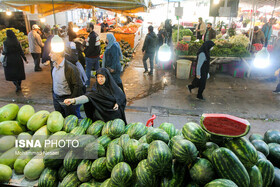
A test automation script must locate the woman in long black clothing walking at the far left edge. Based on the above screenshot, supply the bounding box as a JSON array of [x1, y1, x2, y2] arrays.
[[2, 30, 28, 92]]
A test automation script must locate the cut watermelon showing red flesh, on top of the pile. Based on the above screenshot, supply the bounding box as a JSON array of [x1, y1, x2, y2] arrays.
[[200, 114, 250, 137]]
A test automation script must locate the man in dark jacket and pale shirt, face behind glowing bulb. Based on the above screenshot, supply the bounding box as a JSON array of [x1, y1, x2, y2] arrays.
[[50, 40, 84, 117]]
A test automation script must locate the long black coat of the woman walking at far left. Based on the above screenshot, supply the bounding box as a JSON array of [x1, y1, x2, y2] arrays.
[[2, 40, 26, 81]]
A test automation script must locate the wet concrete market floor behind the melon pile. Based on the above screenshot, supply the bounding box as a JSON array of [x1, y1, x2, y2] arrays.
[[0, 38, 280, 137]]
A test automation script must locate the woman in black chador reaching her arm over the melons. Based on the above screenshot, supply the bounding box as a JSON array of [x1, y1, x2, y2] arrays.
[[64, 68, 126, 124]]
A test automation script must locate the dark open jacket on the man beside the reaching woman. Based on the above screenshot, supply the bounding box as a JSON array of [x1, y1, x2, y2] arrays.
[[51, 59, 84, 98]]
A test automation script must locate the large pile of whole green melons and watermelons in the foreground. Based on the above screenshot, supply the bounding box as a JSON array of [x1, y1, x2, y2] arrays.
[[0, 104, 280, 187]]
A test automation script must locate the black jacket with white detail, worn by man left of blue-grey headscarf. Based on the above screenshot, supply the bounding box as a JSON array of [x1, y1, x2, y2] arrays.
[[85, 31, 100, 58]]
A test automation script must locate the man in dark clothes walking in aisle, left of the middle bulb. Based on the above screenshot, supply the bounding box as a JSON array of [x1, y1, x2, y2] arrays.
[[142, 25, 157, 75]]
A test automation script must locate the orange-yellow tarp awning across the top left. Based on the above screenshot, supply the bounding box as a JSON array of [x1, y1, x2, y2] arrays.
[[2, 0, 147, 16]]
